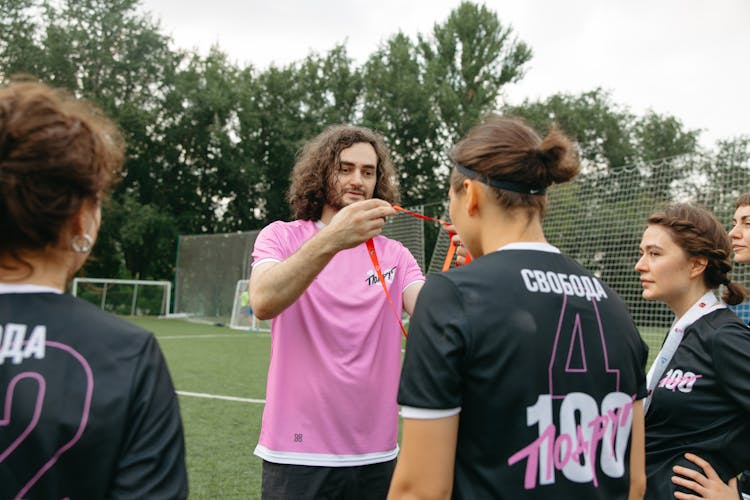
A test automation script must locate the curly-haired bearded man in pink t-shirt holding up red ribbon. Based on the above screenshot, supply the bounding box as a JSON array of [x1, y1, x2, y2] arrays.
[[250, 125, 424, 499]]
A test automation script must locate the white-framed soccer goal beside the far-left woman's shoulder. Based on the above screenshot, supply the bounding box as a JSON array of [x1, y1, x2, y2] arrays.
[[71, 278, 172, 316]]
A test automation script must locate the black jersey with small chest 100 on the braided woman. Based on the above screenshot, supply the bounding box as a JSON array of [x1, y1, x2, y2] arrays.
[[646, 308, 750, 499]]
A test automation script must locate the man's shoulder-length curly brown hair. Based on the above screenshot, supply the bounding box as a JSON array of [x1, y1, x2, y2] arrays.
[[287, 125, 398, 220]]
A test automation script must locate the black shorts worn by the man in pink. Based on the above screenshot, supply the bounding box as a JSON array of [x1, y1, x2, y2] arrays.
[[262, 459, 396, 500]]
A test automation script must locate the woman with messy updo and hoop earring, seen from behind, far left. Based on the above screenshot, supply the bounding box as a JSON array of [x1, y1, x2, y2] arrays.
[[0, 81, 188, 499]]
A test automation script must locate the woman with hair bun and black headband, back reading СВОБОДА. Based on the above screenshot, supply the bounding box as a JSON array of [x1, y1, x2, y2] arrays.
[[390, 116, 648, 500]]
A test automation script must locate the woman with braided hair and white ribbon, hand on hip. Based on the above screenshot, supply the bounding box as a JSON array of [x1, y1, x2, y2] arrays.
[[635, 203, 750, 499]]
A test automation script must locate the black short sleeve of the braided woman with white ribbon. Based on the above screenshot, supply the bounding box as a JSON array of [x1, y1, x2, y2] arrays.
[[712, 323, 750, 414]]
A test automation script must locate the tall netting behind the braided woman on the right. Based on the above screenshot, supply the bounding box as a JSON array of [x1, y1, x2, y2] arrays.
[[429, 148, 750, 355]]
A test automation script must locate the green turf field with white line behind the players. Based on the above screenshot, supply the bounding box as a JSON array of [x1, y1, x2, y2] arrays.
[[128, 318, 664, 499]]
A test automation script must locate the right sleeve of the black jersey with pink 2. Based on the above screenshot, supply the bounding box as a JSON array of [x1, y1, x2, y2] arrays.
[[111, 336, 188, 499]]
